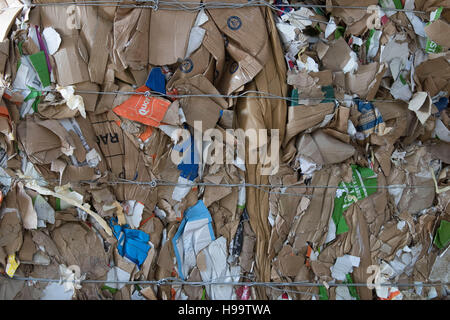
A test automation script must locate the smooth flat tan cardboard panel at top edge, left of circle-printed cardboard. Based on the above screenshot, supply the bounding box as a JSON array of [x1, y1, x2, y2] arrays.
[[148, 0, 198, 66]]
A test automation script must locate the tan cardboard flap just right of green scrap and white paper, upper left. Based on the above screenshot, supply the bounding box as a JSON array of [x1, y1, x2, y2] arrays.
[[54, 37, 90, 87]]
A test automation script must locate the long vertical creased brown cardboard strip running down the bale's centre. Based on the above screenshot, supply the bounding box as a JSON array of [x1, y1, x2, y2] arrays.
[[236, 9, 287, 298]]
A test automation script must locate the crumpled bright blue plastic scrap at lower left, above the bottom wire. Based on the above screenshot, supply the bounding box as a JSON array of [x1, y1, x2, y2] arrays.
[[109, 218, 151, 268]]
